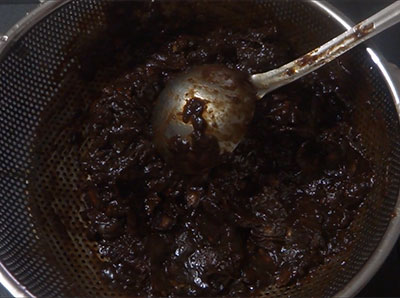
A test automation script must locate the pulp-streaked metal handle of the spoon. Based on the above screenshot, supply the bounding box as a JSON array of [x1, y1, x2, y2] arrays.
[[250, 1, 400, 98]]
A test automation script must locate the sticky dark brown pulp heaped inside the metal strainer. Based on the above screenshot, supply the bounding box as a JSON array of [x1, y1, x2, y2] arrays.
[[75, 1, 373, 296]]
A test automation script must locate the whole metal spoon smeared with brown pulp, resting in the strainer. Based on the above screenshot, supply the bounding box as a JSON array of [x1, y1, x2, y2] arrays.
[[152, 1, 400, 170]]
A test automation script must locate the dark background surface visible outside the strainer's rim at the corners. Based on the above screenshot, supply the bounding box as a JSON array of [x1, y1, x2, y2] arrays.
[[0, 0, 400, 297]]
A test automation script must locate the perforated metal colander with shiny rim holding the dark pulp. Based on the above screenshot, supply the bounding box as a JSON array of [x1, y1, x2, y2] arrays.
[[0, 0, 400, 297]]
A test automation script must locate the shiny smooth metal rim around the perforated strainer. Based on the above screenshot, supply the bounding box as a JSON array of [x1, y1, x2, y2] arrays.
[[0, 0, 400, 297]]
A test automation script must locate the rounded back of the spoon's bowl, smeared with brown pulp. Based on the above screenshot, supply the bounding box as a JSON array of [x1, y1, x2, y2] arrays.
[[152, 65, 257, 159]]
